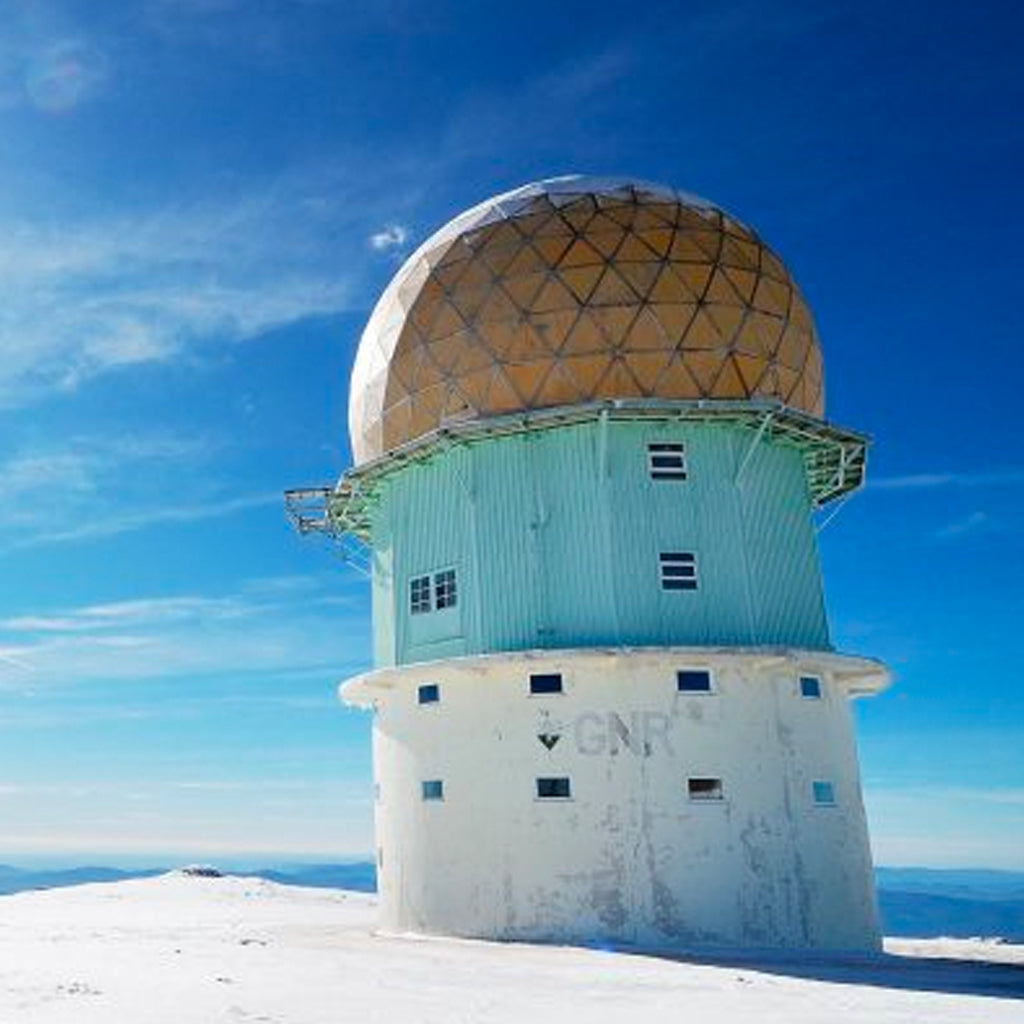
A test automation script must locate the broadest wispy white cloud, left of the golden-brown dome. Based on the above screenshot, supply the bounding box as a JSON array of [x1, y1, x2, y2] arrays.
[[0, 172, 400, 408]]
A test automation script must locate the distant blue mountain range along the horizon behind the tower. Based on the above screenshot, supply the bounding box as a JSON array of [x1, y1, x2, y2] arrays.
[[0, 861, 1024, 943]]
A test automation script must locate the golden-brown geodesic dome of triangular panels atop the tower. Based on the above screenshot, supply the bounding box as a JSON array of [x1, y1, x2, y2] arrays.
[[349, 177, 824, 464]]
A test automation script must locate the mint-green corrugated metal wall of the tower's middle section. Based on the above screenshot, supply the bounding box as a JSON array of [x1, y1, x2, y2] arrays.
[[373, 421, 828, 666]]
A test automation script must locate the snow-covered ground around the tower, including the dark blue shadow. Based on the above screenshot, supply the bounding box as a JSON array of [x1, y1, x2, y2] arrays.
[[0, 873, 1024, 1024]]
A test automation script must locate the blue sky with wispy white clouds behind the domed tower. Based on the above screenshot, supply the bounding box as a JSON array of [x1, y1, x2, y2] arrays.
[[0, 0, 1024, 868]]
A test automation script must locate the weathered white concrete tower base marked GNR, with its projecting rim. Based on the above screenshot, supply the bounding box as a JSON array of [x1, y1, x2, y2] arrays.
[[342, 648, 888, 950]]
